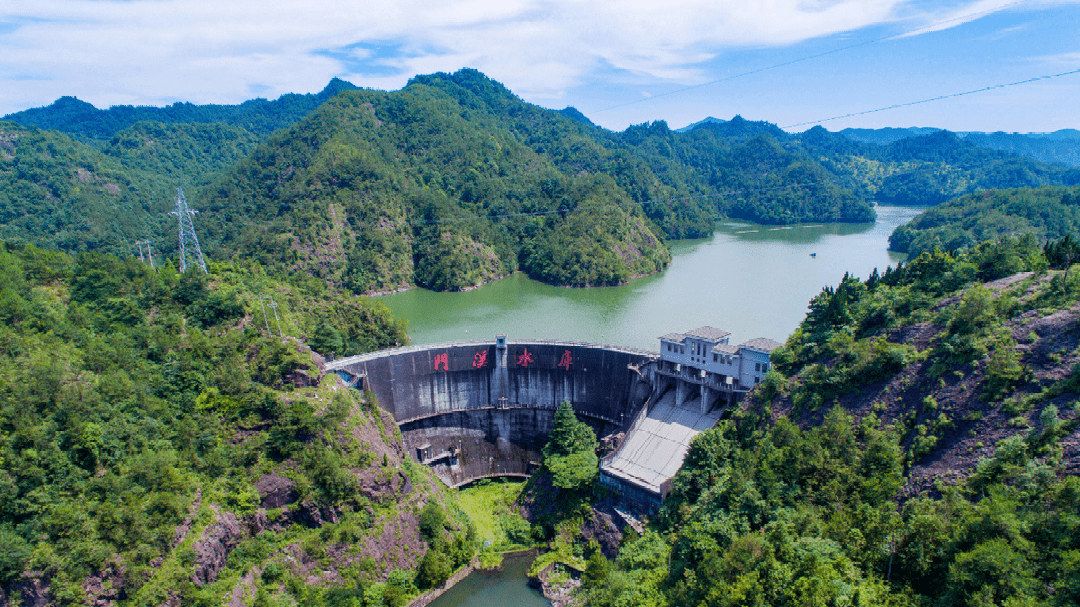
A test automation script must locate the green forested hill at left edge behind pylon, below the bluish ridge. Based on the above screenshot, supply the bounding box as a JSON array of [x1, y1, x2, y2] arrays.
[[0, 122, 256, 255]]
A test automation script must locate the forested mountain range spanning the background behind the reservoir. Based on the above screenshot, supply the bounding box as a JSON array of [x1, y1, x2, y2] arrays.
[[8, 69, 1080, 293]]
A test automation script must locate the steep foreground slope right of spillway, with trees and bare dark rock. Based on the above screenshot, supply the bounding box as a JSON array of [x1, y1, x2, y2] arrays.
[[580, 239, 1080, 606]]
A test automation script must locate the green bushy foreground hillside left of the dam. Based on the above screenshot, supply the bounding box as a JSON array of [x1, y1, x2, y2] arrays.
[[0, 244, 494, 607]]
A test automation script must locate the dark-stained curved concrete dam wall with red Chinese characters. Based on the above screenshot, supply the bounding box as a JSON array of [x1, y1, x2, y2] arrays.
[[326, 340, 657, 486]]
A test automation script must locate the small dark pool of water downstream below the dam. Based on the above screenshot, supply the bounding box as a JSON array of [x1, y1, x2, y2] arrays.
[[429, 556, 551, 607]]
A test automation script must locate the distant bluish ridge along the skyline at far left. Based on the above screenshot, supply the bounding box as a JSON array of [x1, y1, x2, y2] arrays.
[[3, 78, 356, 140]]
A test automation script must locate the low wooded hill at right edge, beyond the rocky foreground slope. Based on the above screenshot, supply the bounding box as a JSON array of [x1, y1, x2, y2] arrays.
[[889, 181, 1080, 256]]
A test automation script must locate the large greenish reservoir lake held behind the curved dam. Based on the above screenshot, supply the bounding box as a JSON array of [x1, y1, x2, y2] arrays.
[[379, 206, 922, 351]]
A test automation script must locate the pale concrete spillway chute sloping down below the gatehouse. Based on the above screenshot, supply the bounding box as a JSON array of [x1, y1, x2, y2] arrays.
[[600, 390, 727, 507]]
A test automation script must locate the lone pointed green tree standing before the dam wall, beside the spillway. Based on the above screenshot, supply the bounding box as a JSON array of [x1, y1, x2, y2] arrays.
[[543, 401, 597, 489]]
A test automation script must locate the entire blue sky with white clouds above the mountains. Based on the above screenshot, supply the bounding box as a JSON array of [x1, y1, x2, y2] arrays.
[[0, 0, 1080, 132]]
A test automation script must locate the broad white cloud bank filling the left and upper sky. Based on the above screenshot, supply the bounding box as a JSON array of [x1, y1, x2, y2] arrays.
[[0, 0, 1067, 114]]
